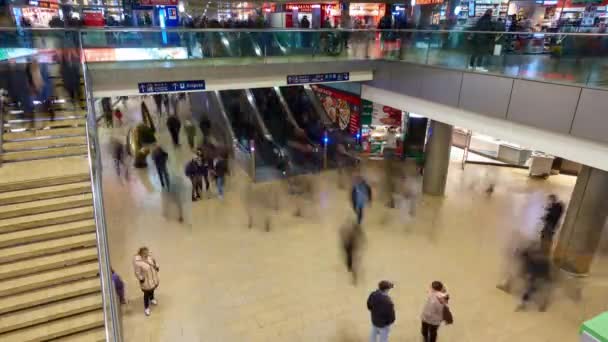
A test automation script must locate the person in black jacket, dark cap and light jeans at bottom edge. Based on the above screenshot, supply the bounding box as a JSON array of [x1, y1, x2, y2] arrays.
[[367, 280, 395, 342]]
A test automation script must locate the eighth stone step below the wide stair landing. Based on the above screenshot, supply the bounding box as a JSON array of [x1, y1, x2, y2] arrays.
[[0, 274, 101, 315]]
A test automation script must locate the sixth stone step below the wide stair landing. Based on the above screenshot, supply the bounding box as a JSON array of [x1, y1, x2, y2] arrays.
[[0, 247, 97, 280]]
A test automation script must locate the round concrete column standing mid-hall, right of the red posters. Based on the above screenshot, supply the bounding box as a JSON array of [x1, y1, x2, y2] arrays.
[[422, 120, 452, 196]]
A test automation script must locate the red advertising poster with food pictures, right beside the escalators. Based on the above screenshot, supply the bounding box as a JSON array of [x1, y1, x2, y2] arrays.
[[311, 85, 361, 134]]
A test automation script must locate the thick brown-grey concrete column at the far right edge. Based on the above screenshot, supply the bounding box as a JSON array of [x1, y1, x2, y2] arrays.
[[553, 166, 608, 275]]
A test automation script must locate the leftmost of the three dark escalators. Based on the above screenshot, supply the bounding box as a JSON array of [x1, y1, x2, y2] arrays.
[[219, 90, 282, 180]]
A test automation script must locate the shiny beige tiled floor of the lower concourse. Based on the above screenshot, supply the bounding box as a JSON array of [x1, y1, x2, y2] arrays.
[[102, 99, 608, 342]]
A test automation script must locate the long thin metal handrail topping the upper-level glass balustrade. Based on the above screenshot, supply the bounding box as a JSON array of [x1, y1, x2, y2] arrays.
[[0, 26, 608, 37]]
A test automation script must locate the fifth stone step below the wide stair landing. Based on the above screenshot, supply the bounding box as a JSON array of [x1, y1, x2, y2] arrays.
[[0, 233, 97, 264]]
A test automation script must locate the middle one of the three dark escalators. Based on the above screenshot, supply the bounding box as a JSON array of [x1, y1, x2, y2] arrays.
[[251, 87, 321, 174]]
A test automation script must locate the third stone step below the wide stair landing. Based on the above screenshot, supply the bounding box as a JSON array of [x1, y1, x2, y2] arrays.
[[0, 206, 94, 234]]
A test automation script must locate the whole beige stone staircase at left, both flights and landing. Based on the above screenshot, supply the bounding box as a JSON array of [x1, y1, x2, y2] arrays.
[[0, 76, 105, 342]]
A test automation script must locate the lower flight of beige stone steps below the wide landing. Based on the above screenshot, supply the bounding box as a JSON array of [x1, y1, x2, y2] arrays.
[[0, 173, 105, 342]]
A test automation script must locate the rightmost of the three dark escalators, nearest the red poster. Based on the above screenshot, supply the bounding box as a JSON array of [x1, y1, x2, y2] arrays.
[[280, 86, 359, 167]]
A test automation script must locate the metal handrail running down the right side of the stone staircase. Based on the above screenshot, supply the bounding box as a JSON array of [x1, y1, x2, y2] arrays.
[[78, 34, 123, 342]]
